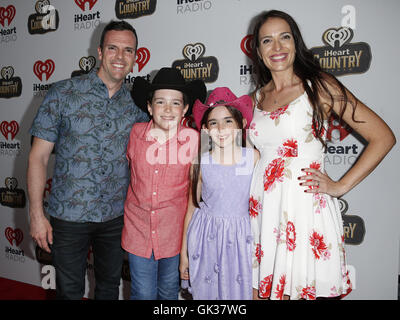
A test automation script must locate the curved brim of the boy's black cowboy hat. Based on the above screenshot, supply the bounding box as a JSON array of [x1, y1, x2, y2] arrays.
[[131, 76, 207, 115]]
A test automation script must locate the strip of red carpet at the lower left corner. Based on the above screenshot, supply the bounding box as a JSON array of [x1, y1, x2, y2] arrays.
[[0, 278, 56, 300]]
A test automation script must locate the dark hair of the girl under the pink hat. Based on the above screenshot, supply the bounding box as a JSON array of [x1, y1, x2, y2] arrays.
[[191, 106, 246, 208]]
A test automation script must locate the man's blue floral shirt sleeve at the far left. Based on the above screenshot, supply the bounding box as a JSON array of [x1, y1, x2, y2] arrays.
[[29, 84, 61, 142]]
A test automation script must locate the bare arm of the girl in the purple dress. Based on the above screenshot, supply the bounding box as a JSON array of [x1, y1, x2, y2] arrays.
[[179, 165, 201, 280]]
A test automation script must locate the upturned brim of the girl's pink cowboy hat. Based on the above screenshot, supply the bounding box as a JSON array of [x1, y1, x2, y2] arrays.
[[193, 95, 253, 130]]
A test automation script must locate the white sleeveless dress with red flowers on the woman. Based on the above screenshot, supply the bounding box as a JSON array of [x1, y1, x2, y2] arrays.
[[249, 93, 351, 300]]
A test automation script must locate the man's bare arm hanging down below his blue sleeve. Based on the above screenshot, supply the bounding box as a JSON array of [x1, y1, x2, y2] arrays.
[[27, 137, 54, 252]]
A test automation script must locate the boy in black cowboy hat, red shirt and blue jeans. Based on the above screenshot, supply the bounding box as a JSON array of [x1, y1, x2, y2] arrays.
[[122, 68, 206, 300]]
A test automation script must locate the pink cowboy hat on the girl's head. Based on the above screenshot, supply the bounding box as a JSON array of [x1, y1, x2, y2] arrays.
[[193, 87, 253, 130]]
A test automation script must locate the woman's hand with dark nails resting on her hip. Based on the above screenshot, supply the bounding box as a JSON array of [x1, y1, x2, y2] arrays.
[[297, 168, 346, 198]]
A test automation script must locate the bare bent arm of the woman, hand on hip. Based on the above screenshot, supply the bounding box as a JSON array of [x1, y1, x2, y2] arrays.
[[299, 81, 396, 197]]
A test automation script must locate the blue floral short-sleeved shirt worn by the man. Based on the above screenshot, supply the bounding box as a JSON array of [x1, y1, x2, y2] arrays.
[[30, 70, 148, 222]]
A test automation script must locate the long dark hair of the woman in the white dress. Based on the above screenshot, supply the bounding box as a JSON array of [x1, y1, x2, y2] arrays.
[[252, 10, 357, 147]]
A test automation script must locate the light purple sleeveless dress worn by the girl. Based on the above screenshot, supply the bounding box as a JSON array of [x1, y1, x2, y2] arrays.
[[187, 148, 254, 300]]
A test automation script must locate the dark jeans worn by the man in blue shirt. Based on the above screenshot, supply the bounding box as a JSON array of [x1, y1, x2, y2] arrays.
[[50, 216, 124, 300]]
